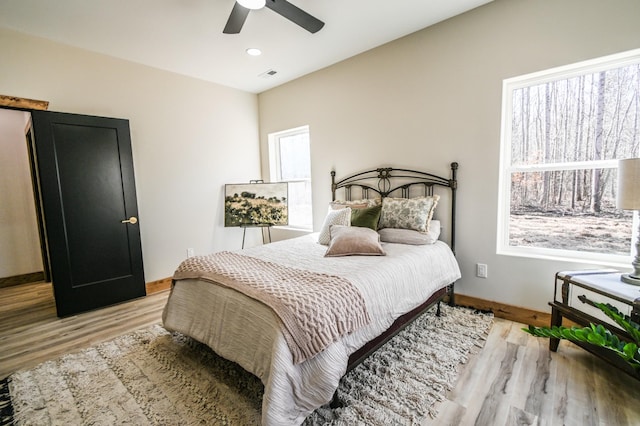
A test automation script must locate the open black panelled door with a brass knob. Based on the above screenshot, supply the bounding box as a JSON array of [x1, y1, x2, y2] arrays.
[[32, 111, 146, 316]]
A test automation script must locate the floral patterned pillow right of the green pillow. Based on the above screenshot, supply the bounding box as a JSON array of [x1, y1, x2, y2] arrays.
[[378, 195, 440, 232]]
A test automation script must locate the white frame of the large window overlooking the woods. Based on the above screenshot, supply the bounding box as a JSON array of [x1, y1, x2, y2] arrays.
[[496, 49, 640, 268]]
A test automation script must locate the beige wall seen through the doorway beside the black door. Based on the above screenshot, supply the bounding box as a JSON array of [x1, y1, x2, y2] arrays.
[[0, 109, 42, 278]]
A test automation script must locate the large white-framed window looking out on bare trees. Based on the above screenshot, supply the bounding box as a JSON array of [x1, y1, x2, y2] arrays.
[[498, 50, 640, 264]]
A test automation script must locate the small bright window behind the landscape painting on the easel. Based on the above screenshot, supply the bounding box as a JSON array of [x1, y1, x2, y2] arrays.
[[269, 126, 313, 230]]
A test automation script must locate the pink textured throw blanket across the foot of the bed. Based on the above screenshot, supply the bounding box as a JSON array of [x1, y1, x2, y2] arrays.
[[173, 251, 370, 364]]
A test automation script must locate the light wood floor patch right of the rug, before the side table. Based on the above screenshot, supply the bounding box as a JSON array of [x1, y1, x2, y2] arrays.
[[423, 318, 640, 426]]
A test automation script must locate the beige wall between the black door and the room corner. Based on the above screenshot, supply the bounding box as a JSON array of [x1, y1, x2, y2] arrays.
[[0, 29, 260, 281]]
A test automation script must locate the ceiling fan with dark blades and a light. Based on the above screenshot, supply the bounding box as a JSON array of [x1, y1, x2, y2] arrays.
[[222, 0, 324, 34]]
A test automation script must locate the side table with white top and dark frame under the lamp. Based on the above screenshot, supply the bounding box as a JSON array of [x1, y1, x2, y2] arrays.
[[549, 269, 640, 379]]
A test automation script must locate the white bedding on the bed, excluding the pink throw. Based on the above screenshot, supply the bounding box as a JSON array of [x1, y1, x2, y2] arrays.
[[163, 235, 460, 426]]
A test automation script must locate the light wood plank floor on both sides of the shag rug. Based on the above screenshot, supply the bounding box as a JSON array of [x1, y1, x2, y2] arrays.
[[0, 283, 640, 426]]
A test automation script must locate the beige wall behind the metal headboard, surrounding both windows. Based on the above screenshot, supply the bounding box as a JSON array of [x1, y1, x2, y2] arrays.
[[258, 0, 640, 310]]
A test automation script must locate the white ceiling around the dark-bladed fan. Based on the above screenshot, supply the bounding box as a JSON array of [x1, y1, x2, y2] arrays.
[[0, 0, 492, 93]]
